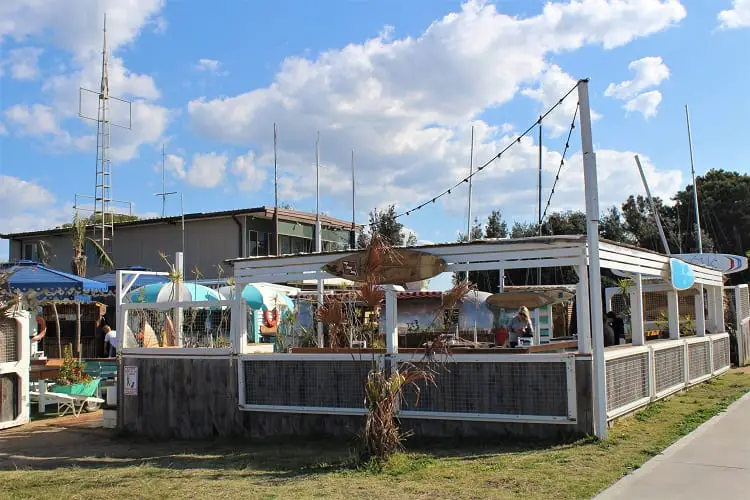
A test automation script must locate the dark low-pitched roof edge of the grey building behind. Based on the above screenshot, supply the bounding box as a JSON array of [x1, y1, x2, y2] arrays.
[[0, 206, 362, 239]]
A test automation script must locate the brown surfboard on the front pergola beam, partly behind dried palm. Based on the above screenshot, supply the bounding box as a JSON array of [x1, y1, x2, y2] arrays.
[[322, 248, 447, 285]]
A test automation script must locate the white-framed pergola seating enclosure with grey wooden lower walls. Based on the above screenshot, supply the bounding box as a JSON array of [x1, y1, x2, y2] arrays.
[[110, 232, 736, 438]]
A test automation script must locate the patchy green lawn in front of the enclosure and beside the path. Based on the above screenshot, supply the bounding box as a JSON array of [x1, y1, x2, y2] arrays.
[[0, 371, 750, 499]]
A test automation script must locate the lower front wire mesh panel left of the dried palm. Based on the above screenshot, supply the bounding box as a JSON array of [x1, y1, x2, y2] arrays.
[[244, 359, 373, 410]]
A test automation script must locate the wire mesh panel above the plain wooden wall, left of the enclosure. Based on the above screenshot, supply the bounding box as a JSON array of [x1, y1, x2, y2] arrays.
[[123, 304, 232, 348]]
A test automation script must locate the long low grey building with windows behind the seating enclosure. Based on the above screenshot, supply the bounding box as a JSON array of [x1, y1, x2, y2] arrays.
[[0, 207, 361, 279]]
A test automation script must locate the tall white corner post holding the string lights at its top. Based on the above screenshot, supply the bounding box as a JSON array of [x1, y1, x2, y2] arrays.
[[578, 80, 607, 439]]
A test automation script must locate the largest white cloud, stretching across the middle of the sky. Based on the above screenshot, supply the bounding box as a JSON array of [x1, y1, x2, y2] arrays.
[[188, 0, 685, 219]]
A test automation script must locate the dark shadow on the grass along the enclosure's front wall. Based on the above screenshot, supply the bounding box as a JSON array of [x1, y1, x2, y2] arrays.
[[0, 426, 580, 482]]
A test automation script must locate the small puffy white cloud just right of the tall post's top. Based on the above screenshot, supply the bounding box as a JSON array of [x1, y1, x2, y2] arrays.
[[604, 57, 669, 118]]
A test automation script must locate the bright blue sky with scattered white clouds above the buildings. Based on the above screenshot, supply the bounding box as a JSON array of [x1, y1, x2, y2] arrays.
[[0, 0, 750, 292]]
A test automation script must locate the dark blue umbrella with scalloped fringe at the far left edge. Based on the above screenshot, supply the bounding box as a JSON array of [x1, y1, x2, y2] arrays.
[[0, 260, 108, 301]]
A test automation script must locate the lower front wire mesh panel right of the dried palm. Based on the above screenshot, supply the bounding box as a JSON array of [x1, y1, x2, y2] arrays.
[[402, 362, 568, 417]]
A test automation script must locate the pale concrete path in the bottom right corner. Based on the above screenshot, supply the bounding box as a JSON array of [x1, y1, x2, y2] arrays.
[[597, 393, 750, 500]]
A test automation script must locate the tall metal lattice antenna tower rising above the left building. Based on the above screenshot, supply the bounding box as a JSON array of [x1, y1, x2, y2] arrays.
[[78, 14, 133, 255]]
